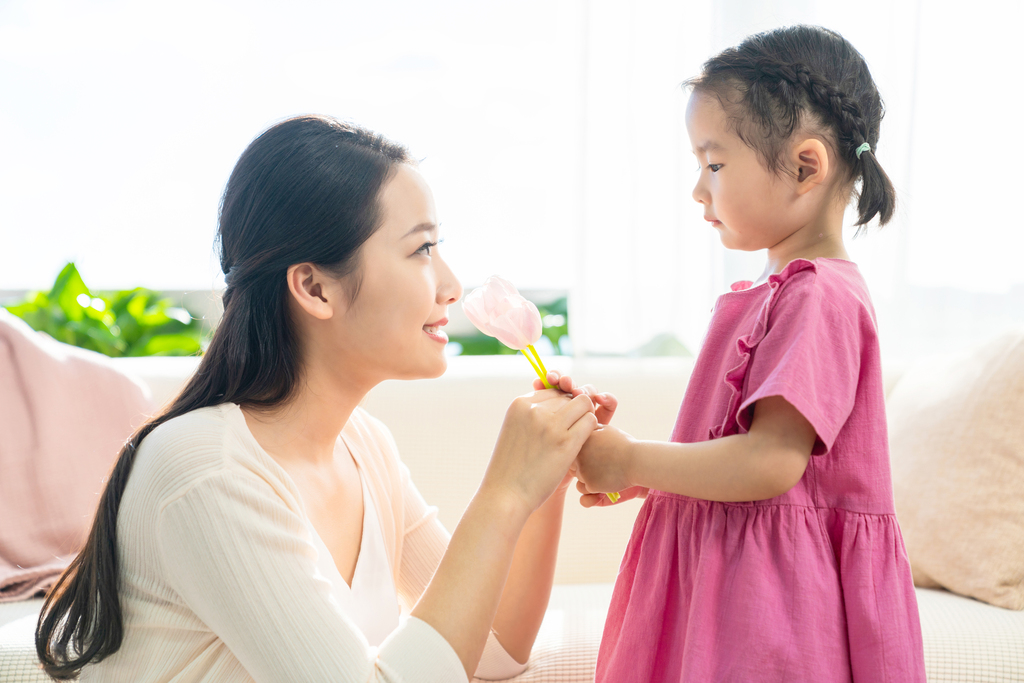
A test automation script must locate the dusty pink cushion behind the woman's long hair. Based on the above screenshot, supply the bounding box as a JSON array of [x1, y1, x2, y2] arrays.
[[0, 308, 153, 601]]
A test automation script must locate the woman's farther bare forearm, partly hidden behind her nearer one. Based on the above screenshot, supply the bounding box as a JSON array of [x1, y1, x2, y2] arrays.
[[493, 490, 565, 664]]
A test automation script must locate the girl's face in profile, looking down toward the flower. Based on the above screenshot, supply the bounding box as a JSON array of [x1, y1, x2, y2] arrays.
[[686, 92, 801, 251]]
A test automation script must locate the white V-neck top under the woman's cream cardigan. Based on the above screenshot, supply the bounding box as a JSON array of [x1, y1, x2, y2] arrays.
[[308, 469, 400, 647]]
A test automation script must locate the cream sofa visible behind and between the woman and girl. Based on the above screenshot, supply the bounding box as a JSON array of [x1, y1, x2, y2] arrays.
[[0, 356, 1024, 683]]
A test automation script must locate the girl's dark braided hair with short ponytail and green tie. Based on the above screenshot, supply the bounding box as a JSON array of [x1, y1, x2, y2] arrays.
[[686, 26, 896, 226]]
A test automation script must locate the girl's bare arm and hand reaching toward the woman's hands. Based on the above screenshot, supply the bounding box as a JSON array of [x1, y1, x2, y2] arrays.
[[577, 396, 817, 507]]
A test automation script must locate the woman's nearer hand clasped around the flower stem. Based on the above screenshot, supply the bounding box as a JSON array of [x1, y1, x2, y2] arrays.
[[480, 389, 597, 512]]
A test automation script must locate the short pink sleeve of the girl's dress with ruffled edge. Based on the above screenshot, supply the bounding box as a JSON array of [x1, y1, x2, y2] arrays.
[[736, 268, 863, 456]]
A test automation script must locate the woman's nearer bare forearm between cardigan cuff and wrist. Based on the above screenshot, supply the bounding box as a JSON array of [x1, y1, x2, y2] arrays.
[[412, 488, 529, 678]]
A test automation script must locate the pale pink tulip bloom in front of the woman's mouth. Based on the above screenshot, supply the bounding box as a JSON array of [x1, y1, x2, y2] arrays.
[[462, 275, 543, 351]]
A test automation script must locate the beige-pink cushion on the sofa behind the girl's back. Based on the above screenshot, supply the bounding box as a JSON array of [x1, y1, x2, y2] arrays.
[[888, 332, 1024, 609]]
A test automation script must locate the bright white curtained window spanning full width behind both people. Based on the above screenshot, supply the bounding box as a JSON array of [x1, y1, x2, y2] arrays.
[[0, 0, 1024, 357]]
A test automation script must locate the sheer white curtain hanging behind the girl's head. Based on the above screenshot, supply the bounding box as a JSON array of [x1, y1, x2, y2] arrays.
[[571, 0, 1024, 357]]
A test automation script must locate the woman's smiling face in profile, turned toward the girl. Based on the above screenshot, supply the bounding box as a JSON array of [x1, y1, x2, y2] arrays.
[[338, 164, 462, 383]]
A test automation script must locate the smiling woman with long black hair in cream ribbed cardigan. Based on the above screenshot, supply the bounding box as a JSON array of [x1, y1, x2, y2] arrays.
[[36, 117, 598, 682]]
